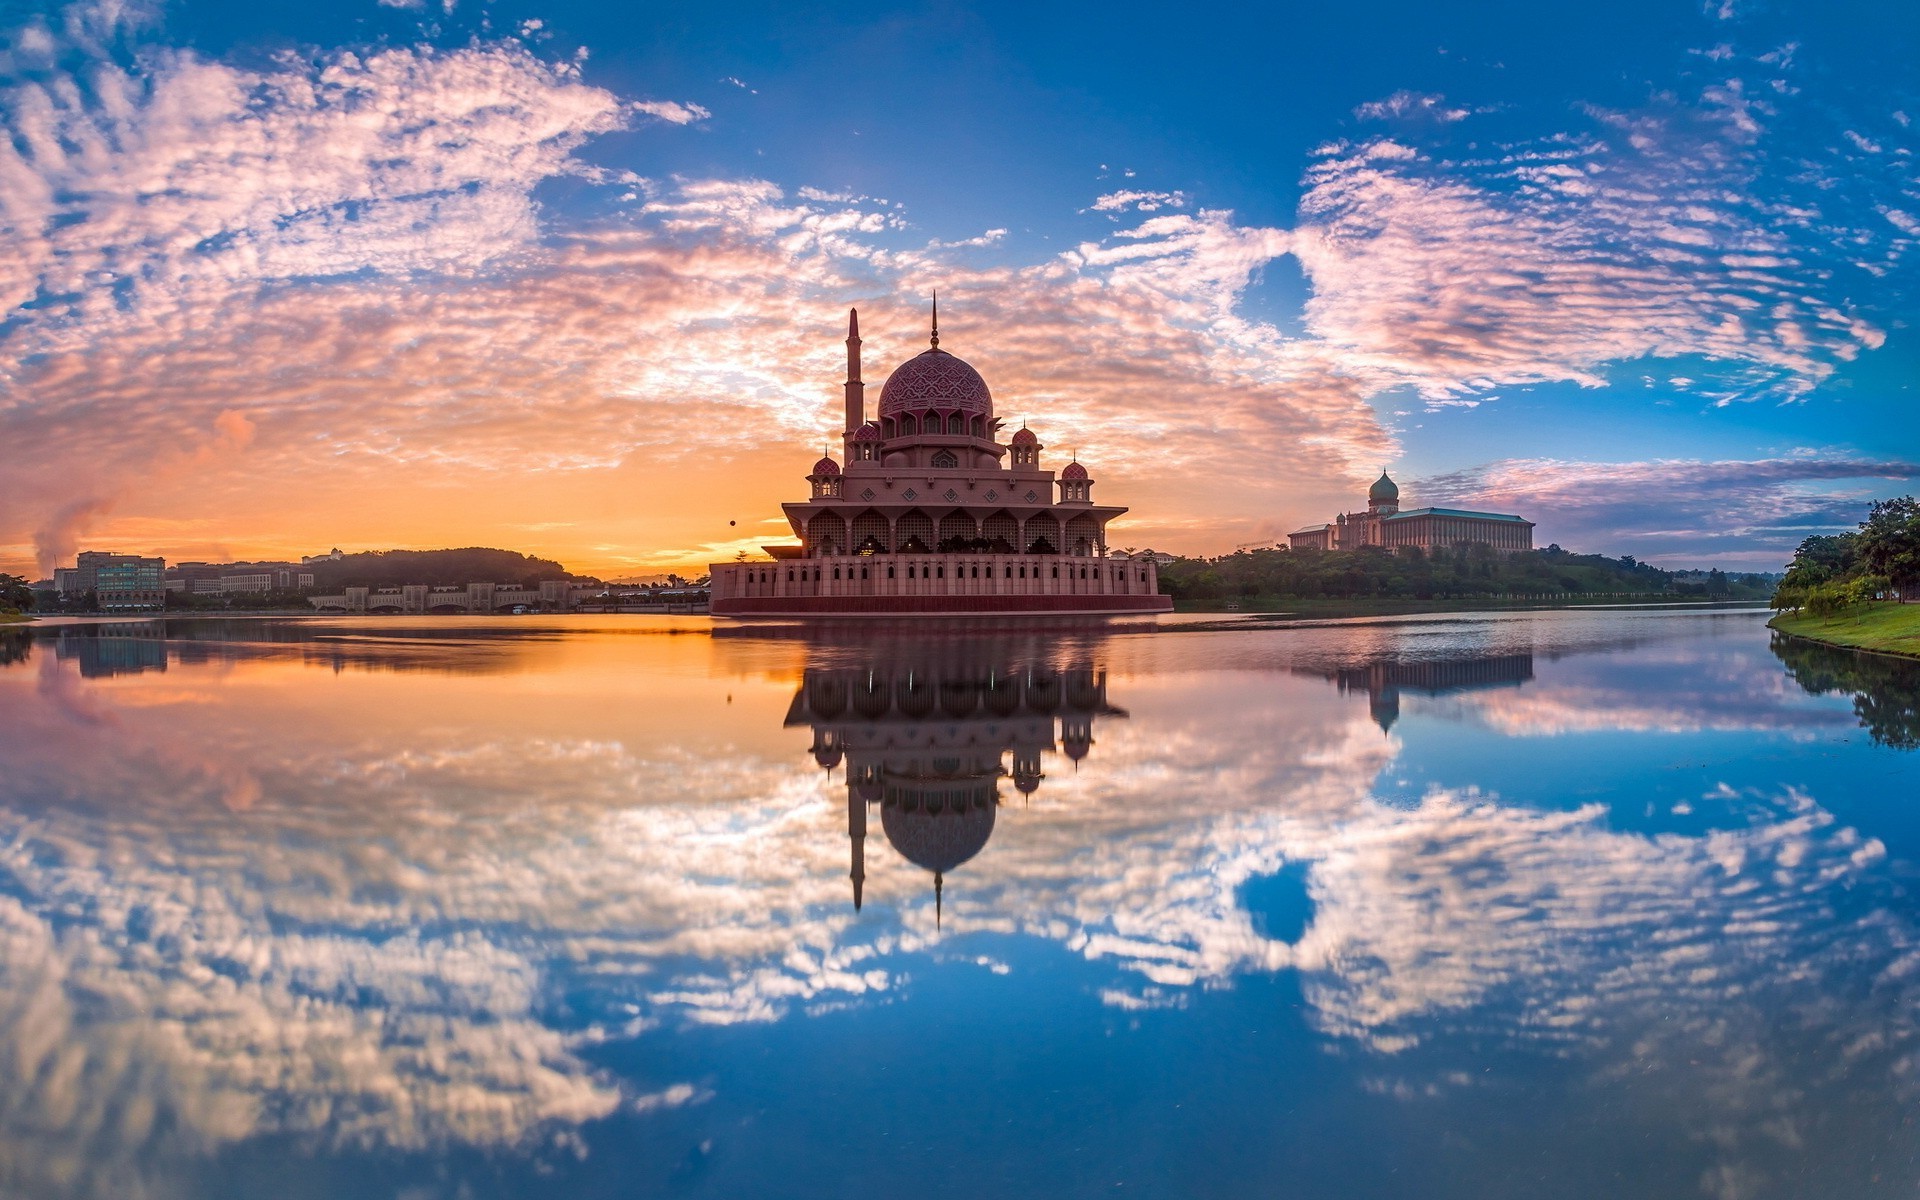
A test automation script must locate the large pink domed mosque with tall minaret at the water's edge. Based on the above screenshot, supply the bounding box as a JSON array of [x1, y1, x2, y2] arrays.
[[710, 309, 1173, 616]]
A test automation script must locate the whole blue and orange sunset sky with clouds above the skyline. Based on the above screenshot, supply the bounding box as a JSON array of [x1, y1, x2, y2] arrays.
[[0, 0, 1920, 578]]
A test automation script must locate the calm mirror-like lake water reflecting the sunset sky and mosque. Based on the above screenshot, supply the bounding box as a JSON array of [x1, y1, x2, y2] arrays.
[[0, 611, 1920, 1200]]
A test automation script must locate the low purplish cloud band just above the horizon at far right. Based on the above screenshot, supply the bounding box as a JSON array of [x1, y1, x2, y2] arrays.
[[1409, 451, 1920, 570]]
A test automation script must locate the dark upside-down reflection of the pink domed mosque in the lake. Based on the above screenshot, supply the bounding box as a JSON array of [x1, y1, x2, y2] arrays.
[[787, 664, 1127, 916]]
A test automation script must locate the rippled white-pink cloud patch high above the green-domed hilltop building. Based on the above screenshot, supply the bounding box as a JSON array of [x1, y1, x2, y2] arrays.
[[1294, 101, 1884, 399]]
